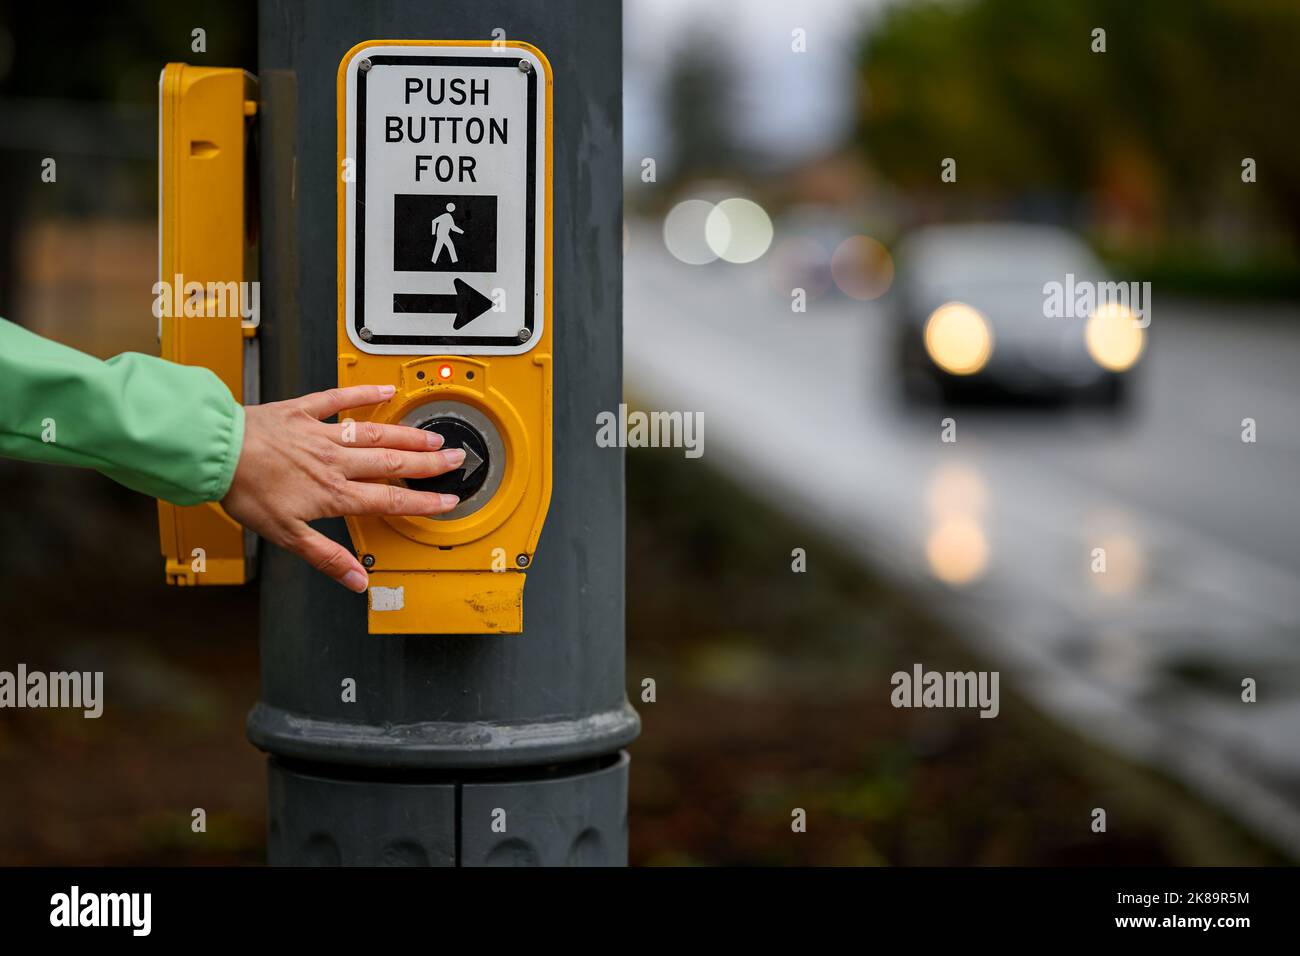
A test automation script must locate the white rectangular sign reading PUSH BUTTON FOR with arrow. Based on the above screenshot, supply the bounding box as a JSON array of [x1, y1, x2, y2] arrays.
[[343, 44, 549, 355]]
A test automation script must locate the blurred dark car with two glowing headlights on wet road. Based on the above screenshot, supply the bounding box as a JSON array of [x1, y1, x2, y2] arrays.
[[894, 222, 1145, 407]]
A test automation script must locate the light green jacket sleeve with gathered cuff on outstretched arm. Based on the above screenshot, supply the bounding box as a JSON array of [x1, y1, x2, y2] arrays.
[[0, 319, 244, 505]]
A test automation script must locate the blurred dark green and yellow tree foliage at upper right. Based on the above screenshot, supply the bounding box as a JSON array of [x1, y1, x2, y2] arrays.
[[858, 0, 1300, 247]]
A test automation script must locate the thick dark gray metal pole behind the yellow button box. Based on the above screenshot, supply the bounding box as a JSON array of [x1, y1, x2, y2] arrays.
[[248, 0, 640, 866]]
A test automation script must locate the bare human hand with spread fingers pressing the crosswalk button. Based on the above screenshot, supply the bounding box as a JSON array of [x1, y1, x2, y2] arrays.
[[221, 385, 465, 592]]
